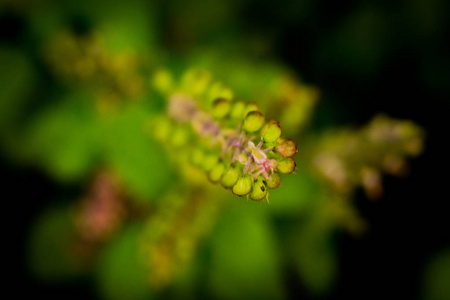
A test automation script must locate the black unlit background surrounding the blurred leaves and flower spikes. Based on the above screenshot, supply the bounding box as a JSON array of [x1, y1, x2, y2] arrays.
[[0, 0, 450, 299]]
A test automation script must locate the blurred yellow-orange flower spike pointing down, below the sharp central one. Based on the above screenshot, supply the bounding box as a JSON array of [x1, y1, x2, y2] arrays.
[[140, 189, 223, 289]]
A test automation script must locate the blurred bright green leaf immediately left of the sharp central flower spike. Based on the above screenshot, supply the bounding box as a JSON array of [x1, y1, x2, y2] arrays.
[[101, 105, 172, 201]]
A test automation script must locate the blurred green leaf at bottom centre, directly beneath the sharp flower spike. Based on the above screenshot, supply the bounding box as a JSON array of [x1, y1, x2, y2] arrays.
[[209, 206, 283, 299]]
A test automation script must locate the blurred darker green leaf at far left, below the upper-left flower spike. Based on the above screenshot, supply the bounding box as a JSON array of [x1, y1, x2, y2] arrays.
[[24, 92, 98, 181]]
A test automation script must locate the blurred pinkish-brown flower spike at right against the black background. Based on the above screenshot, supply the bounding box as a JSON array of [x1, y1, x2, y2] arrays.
[[312, 115, 424, 199]]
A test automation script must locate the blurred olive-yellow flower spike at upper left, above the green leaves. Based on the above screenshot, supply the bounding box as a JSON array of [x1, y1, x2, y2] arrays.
[[45, 30, 144, 110]]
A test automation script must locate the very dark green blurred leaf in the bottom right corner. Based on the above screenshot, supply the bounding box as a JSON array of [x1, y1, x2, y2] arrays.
[[421, 249, 450, 300]]
